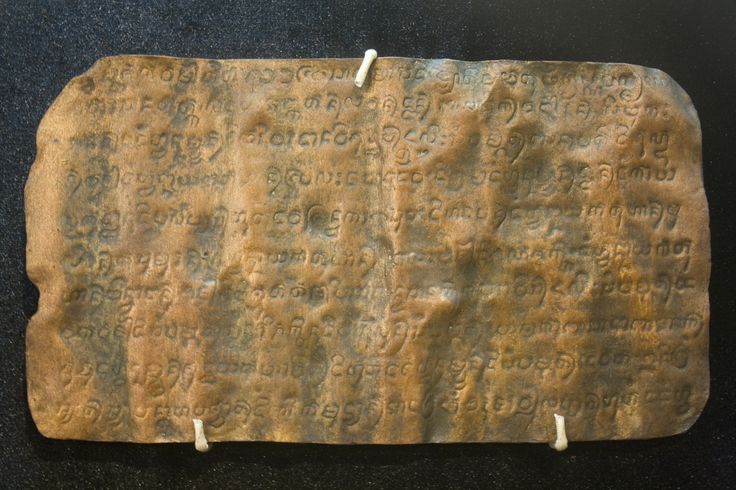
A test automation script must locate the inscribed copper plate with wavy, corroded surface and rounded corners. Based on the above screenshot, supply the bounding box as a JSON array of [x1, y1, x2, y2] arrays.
[[26, 56, 710, 443]]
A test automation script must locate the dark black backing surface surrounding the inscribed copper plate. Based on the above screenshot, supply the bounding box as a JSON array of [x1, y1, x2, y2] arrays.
[[0, 0, 736, 488]]
